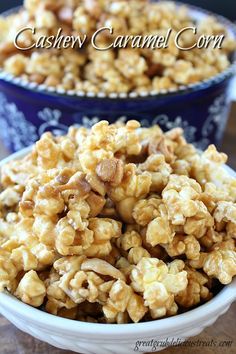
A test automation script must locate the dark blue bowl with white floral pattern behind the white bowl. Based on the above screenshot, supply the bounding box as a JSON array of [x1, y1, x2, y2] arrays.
[[0, 7, 236, 151]]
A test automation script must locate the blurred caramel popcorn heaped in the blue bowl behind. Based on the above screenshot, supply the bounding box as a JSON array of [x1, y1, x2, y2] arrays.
[[0, 0, 235, 94]]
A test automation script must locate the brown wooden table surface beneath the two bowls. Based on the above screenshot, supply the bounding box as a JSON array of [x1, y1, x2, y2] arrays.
[[0, 109, 236, 354]]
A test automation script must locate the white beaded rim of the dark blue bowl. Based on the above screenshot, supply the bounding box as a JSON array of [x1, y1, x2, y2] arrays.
[[0, 0, 236, 101]]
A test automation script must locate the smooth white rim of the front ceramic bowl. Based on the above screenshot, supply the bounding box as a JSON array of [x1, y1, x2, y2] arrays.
[[0, 145, 236, 339]]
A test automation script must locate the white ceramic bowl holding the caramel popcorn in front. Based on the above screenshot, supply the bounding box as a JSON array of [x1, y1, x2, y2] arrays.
[[0, 148, 236, 354]]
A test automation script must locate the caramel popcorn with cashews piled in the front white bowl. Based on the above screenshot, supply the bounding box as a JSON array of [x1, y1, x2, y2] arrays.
[[0, 120, 236, 323]]
